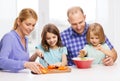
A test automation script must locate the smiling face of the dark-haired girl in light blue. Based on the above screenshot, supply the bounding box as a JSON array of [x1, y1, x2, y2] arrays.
[[46, 32, 58, 48]]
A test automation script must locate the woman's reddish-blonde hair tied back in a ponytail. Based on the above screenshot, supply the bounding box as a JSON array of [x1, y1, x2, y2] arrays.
[[13, 8, 38, 30]]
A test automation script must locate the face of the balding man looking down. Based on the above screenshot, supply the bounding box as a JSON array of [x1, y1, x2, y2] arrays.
[[68, 11, 85, 34]]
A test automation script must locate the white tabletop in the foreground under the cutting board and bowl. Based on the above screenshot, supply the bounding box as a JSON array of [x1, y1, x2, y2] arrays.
[[0, 63, 120, 81]]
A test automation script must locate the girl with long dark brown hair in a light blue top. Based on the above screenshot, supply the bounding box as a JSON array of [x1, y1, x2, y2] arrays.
[[36, 24, 67, 67]]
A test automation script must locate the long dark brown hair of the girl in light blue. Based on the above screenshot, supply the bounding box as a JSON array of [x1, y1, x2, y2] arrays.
[[41, 23, 62, 51]]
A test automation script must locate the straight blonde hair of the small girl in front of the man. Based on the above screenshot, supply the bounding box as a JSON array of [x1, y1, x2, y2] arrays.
[[86, 23, 105, 44]]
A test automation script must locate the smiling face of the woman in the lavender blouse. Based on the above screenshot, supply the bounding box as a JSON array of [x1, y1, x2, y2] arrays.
[[18, 18, 36, 36]]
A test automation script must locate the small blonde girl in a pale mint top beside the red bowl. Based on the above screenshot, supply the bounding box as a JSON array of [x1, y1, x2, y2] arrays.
[[80, 23, 113, 64]]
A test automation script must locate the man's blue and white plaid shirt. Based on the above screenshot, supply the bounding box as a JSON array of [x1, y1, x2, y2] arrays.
[[60, 24, 113, 66]]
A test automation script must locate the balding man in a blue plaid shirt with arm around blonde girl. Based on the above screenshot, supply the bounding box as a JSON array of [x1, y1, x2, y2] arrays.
[[61, 7, 117, 66]]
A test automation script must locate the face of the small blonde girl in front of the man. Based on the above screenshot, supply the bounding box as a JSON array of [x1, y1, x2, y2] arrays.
[[90, 32, 100, 46]]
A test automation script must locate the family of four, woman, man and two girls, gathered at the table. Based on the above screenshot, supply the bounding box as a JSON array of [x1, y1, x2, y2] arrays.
[[0, 7, 117, 73]]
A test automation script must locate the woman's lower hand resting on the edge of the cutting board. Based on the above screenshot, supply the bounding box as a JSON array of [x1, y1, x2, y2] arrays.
[[24, 62, 44, 74]]
